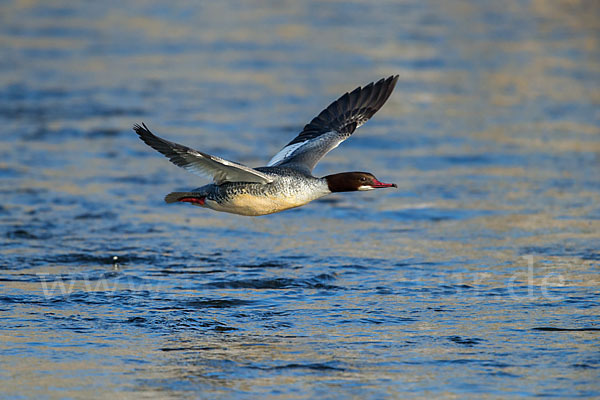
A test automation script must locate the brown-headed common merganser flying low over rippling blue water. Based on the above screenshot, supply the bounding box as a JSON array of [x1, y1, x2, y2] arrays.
[[133, 75, 398, 216]]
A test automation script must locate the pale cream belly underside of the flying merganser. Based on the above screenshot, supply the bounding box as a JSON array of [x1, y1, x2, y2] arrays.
[[205, 193, 313, 216]]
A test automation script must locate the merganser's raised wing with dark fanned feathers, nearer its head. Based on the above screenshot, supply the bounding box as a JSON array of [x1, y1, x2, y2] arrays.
[[268, 75, 398, 173]]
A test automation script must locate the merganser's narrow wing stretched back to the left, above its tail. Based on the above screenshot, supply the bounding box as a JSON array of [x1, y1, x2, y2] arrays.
[[133, 123, 273, 185]]
